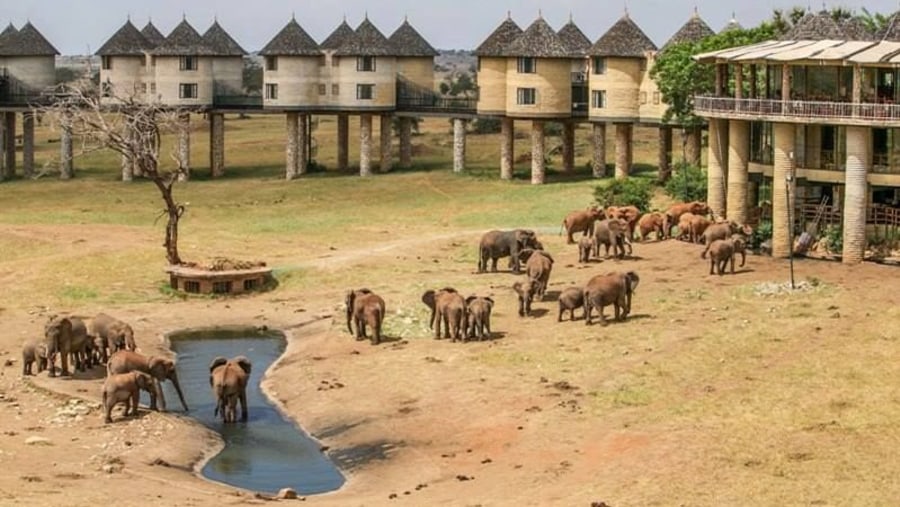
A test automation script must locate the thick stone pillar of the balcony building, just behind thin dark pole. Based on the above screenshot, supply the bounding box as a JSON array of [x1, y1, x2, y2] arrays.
[[772, 123, 795, 257]]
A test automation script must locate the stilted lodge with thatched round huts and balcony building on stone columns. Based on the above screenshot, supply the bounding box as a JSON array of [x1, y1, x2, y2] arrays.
[[0, 11, 900, 262]]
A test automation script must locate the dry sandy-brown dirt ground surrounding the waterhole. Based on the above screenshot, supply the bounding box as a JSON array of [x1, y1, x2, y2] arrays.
[[0, 226, 900, 506]]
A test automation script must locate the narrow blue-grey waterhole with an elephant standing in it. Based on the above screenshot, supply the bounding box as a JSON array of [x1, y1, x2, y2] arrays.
[[163, 329, 344, 495]]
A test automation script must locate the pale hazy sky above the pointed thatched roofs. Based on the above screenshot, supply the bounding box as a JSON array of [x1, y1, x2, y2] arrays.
[[0, 0, 898, 54]]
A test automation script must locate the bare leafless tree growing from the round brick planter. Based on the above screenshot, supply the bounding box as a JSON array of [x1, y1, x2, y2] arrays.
[[42, 80, 190, 265]]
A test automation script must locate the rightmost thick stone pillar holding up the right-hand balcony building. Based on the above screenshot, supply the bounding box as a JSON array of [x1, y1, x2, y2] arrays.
[[843, 127, 872, 264]]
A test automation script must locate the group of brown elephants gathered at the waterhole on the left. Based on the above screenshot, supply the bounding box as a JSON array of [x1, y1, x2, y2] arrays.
[[22, 313, 251, 423]]
